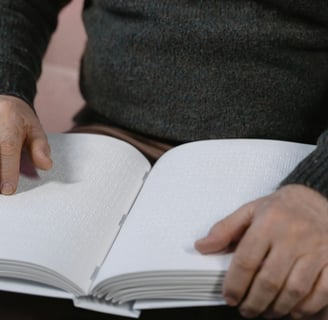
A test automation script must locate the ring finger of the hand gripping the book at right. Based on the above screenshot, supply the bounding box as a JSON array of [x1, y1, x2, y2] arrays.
[[270, 255, 322, 317]]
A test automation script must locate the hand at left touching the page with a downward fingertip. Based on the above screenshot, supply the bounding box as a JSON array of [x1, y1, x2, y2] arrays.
[[0, 95, 52, 195]]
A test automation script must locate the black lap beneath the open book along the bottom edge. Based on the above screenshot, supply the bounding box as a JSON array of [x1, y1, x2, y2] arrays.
[[0, 292, 272, 320]]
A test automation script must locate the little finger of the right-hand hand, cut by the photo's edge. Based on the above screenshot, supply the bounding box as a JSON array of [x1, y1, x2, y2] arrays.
[[291, 267, 328, 319]]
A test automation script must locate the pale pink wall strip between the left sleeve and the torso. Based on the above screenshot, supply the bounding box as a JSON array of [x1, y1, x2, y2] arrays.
[[35, 0, 86, 132]]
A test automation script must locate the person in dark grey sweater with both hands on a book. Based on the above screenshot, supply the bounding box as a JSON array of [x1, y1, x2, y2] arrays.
[[0, 0, 328, 319]]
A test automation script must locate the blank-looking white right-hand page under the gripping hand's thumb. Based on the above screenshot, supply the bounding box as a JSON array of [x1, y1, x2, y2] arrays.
[[94, 140, 314, 285]]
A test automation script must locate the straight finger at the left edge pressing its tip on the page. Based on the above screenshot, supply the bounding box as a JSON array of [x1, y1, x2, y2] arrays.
[[0, 132, 23, 195]]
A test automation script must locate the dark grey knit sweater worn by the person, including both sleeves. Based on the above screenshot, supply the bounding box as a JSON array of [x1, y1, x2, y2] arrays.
[[0, 0, 328, 197]]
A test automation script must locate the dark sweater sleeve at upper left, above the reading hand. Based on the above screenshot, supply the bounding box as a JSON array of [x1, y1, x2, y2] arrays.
[[0, 0, 69, 106]]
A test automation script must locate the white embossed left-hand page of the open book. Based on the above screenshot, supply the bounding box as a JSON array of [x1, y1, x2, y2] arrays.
[[0, 134, 150, 292]]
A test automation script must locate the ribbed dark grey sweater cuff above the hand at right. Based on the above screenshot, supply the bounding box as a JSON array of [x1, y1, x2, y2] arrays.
[[281, 130, 328, 198]]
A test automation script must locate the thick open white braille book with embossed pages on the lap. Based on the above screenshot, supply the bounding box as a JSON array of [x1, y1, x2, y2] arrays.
[[0, 133, 314, 317]]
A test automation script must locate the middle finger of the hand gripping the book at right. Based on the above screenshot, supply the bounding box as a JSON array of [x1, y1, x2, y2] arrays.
[[240, 248, 294, 318]]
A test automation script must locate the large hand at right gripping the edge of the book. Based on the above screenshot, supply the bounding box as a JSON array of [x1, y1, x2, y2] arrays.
[[195, 184, 328, 319]]
